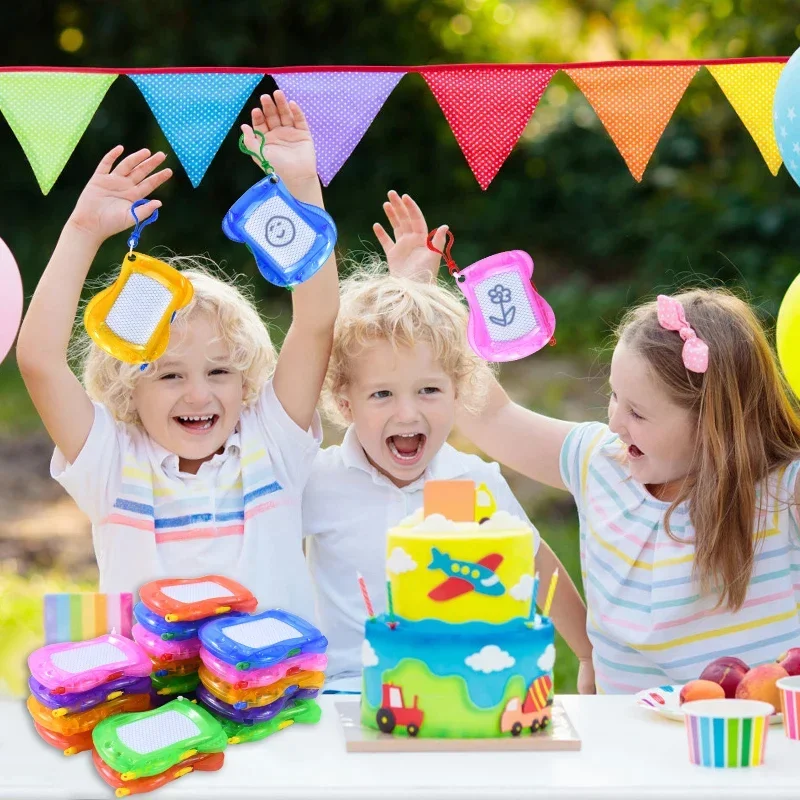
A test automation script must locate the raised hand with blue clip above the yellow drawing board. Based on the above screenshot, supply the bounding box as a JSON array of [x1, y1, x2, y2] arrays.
[[69, 145, 172, 245]]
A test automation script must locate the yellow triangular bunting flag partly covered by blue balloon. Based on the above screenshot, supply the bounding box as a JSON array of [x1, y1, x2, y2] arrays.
[[707, 63, 784, 175]]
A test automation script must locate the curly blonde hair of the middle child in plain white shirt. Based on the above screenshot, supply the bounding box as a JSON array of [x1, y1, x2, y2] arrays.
[[321, 261, 493, 427]]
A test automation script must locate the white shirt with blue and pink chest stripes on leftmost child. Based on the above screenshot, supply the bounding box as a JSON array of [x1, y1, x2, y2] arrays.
[[50, 381, 322, 621]]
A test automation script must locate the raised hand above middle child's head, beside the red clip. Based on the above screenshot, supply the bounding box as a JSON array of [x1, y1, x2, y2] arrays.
[[372, 190, 447, 281]]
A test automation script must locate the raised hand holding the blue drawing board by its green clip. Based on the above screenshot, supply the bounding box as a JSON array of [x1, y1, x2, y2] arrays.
[[242, 89, 317, 187]]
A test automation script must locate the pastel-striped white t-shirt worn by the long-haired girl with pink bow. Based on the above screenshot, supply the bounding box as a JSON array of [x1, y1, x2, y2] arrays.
[[561, 422, 800, 693]]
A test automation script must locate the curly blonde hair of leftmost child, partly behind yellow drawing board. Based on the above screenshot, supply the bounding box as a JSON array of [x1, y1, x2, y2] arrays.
[[76, 256, 277, 424]]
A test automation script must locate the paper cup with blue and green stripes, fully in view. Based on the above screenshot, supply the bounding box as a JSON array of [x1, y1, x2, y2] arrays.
[[681, 700, 775, 767]]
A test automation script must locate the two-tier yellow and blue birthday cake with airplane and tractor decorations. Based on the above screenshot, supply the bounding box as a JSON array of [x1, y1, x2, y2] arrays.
[[361, 481, 555, 738]]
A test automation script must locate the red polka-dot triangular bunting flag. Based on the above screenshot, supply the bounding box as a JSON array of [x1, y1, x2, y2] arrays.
[[420, 65, 558, 189]]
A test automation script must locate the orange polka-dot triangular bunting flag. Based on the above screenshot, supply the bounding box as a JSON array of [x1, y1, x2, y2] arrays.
[[564, 64, 699, 181]]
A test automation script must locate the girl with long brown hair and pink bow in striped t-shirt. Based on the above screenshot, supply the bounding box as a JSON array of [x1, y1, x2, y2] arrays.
[[459, 289, 800, 692]]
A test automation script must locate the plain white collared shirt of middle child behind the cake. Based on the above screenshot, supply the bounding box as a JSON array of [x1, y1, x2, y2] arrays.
[[303, 427, 539, 689]]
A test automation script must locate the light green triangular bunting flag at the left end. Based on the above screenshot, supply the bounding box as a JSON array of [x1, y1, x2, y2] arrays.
[[0, 71, 117, 194]]
